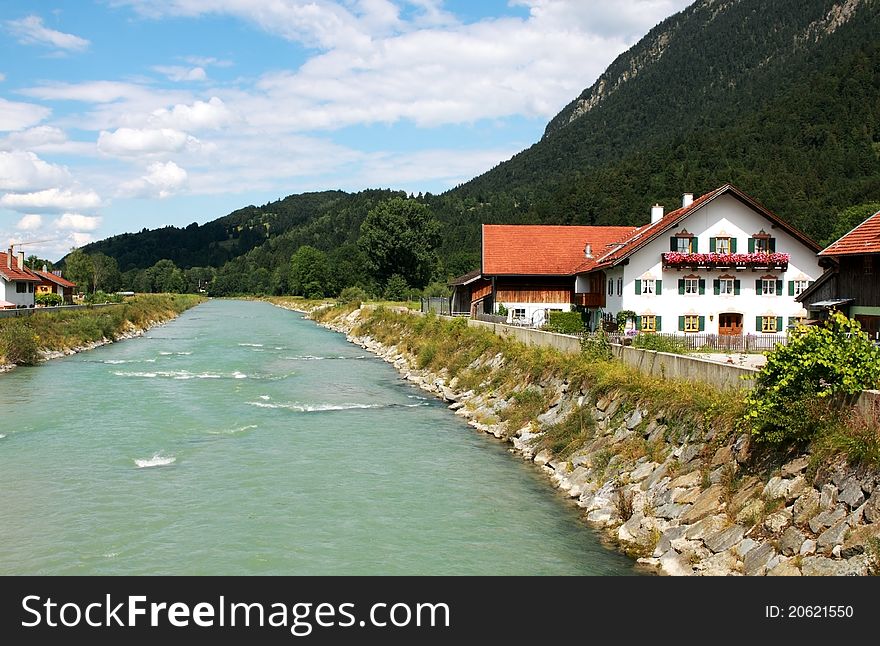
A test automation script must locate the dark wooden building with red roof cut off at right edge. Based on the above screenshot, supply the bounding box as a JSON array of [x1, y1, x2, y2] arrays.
[[798, 211, 880, 339]]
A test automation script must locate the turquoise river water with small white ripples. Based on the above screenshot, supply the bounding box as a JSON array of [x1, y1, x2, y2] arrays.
[[0, 301, 636, 575]]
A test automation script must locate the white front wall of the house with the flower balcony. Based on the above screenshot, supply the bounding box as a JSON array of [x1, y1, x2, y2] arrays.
[[606, 195, 822, 334]]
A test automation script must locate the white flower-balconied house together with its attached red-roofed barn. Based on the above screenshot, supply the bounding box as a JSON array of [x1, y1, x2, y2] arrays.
[[482, 184, 821, 335]]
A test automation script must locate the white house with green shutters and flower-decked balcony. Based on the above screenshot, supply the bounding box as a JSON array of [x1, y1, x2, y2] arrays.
[[575, 184, 822, 335]]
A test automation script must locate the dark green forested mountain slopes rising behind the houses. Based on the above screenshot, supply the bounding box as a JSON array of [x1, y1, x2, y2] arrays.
[[77, 0, 880, 293]]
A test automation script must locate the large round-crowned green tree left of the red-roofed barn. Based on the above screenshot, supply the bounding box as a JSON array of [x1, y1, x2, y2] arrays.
[[359, 197, 440, 289]]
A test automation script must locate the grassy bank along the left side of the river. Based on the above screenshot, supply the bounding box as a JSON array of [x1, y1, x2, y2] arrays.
[[0, 294, 204, 365]]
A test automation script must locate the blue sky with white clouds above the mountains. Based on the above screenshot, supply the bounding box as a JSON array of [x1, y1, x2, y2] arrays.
[[0, 0, 689, 259]]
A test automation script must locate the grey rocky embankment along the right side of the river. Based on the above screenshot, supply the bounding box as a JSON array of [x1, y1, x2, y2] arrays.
[[323, 310, 880, 576]]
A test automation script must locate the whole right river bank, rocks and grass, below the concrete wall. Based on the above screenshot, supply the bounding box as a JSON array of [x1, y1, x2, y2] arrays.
[[304, 309, 880, 576]]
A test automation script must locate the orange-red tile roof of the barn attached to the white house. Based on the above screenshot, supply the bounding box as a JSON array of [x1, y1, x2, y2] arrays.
[[483, 224, 636, 276]]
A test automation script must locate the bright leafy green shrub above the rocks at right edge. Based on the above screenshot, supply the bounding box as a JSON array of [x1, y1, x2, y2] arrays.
[[743, 312, 880, 445]]
